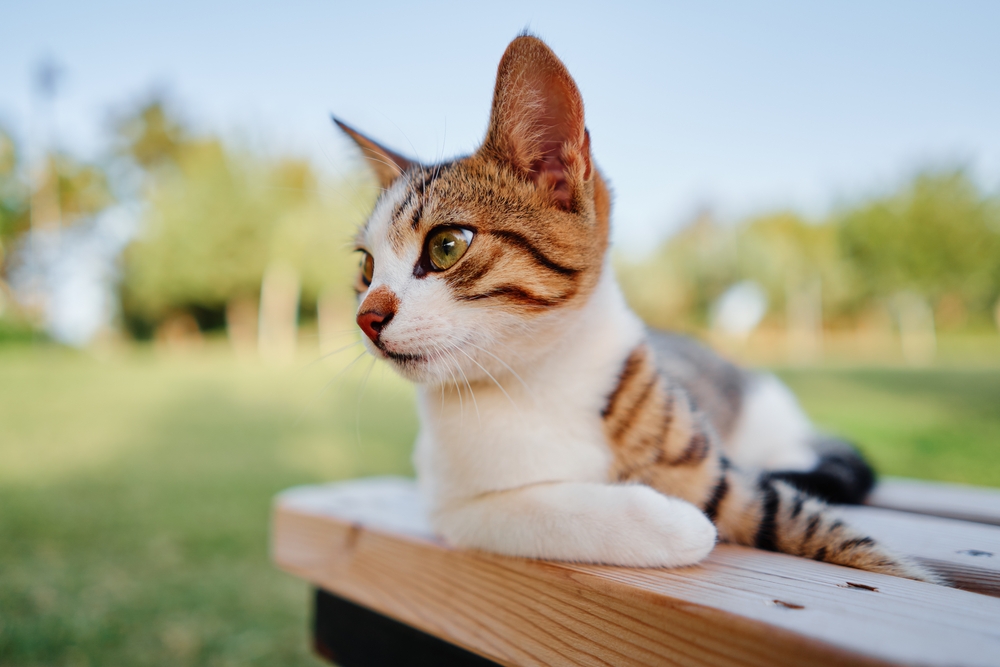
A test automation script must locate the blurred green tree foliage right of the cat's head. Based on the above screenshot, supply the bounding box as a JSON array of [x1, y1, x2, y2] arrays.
[[619, 171, 1000, 328]]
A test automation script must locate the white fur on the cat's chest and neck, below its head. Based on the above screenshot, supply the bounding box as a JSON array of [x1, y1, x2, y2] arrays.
[[414, 269, 643, 507]]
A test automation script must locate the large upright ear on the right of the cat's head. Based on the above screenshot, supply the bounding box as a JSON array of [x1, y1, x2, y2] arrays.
[[480, 35, 593, 210]]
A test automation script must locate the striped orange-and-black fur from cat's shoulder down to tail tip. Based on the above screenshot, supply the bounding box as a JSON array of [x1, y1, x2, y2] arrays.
[[603, 342, 928, 579]]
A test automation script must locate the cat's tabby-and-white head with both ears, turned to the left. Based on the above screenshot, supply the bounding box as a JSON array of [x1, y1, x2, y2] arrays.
[[338, 36, 610, 384]]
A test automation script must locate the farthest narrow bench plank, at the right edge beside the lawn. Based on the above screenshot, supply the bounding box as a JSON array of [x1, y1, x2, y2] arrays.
[[868, 477, 1000, 526]]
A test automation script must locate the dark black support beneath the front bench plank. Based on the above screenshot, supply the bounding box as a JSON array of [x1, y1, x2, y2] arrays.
[[313, 588, 497, 667]]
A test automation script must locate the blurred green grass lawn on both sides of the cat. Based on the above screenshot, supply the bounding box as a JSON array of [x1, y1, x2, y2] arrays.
[[0, 345, 1000, 667]]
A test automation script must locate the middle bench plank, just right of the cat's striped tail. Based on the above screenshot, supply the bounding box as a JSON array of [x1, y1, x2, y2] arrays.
[[837, 507, 1000, 596]]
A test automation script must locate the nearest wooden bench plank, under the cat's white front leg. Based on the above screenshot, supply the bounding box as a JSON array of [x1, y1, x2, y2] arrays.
[[272, 479, 1000, 666]]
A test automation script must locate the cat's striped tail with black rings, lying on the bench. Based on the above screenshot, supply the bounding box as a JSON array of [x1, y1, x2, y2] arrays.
[[704, 459, 944, 583]]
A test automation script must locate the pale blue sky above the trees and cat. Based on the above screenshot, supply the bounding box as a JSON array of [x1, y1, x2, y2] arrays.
[[0, 0, 1000, 251]]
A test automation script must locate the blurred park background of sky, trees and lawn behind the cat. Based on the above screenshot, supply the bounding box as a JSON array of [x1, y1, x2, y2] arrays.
[[0, 0, 1000, 666]]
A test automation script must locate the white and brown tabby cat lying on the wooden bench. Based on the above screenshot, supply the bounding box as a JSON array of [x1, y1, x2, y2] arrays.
[[334, 34, 938, 581]]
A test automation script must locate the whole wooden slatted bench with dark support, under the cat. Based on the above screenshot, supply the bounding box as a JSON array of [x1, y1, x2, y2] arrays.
[[271, 478, 1000, 667]]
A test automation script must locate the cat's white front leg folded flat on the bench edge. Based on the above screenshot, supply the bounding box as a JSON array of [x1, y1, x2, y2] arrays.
[[433, 482, 716, 567]]
